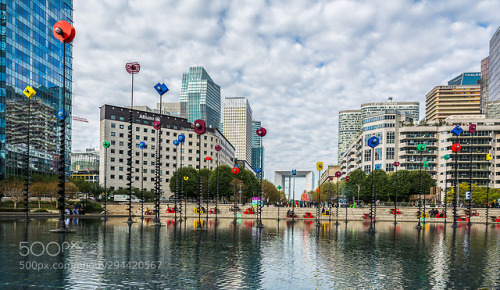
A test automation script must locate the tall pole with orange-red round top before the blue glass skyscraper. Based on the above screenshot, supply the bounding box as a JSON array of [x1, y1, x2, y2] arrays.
[[51, 20, 76, 232]]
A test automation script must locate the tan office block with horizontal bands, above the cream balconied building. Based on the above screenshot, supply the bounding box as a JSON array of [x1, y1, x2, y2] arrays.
[[425, 85, 481, 121]]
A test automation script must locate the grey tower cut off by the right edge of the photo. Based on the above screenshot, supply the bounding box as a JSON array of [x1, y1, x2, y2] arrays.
[[488, 27, 500, 118]]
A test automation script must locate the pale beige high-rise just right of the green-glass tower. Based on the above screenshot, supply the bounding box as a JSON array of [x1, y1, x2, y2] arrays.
[[224, 97, 252, 165]]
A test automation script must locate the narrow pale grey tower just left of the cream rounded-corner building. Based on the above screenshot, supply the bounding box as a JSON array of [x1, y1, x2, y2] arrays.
[[337, 110, 361, 162]]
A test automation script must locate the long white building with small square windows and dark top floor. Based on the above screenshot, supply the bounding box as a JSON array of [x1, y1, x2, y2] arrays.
[[99, 105, 235, 196]]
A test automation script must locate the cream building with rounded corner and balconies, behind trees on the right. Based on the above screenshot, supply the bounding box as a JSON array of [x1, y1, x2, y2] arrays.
[[340, 114, 500, 200]]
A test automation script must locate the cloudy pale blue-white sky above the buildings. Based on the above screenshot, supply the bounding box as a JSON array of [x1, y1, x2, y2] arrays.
[[72, 0, 500, 193]]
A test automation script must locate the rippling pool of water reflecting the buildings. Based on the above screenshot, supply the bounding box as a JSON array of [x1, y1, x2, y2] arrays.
[[0, 218, 500, 289]]
